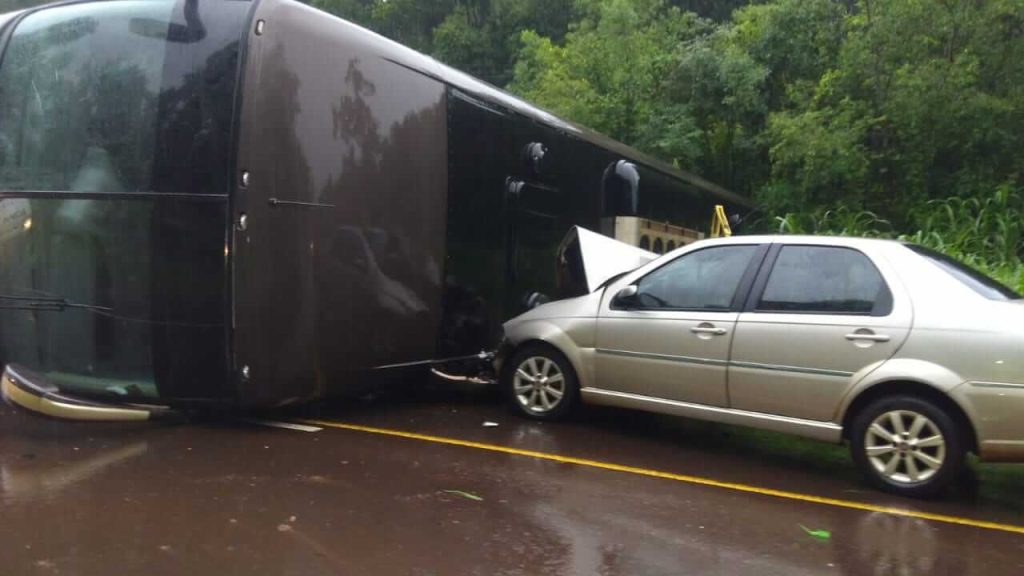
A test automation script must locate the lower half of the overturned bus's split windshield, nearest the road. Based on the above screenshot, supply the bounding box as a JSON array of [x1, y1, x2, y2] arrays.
[[0, 197, 226, 400]]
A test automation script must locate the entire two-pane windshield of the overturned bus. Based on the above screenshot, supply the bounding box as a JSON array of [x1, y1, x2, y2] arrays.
[[0, 0, 250, 399]]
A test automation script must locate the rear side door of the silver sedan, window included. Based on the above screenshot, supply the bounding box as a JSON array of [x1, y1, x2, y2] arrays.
[[728, 239, 912, 421]]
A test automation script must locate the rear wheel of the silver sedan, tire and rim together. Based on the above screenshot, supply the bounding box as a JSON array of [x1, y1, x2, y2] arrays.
[[850, 396, 967, 498]]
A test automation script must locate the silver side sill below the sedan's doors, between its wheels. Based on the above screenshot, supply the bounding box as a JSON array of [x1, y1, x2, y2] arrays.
[[580, 387, 843, 443]]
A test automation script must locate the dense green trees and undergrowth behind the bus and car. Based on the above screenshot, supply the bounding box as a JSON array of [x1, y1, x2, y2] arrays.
[[6, 0, 1024, 286]]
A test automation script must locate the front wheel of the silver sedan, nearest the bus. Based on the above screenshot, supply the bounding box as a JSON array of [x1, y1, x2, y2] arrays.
[[501, 343, 580, 420]]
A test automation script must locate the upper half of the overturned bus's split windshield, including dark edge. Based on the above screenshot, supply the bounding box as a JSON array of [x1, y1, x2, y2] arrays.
[[0, 0, 247, 194]]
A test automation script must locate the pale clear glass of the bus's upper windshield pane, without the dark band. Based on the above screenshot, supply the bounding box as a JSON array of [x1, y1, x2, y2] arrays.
[[0, 0, 174, 193]]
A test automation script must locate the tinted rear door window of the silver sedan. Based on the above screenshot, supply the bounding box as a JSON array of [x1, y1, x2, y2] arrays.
[[758, 246, 891, 315]]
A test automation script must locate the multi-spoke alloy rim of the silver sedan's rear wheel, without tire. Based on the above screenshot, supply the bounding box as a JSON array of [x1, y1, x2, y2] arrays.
[[864, 410, 946, 484]]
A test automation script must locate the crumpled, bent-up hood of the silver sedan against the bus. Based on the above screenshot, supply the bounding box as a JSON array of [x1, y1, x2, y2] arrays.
[[558, 227, 657, 296]]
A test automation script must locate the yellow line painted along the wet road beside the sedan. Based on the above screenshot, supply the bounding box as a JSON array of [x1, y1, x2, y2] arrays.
[[302, 420, 1024, 534]]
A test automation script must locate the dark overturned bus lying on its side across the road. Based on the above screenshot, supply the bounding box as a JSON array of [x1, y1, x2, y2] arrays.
[[0, 0, 749, 408]]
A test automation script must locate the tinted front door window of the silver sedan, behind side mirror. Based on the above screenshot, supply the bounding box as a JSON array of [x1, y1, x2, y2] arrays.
[[637, 246, 757, 311]]
